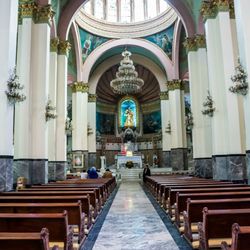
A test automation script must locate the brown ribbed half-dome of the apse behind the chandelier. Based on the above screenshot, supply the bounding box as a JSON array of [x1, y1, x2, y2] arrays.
[[96, 65, 160, 104]]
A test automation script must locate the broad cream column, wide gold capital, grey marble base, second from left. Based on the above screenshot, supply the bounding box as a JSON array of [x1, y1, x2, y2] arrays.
[[14, 2, 53, 183]]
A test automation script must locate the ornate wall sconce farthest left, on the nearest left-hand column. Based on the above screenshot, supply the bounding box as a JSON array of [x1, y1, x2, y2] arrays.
[[5, 67, 26, 104]]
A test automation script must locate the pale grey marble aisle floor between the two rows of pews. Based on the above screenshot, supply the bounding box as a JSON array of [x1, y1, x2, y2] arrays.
[[93, 182, 179, 250]]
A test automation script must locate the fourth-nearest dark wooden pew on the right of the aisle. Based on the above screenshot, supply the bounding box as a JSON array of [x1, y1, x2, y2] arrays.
[[175, 192, 250, 227]]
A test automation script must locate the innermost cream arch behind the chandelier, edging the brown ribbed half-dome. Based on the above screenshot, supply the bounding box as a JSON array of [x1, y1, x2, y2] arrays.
[[89, 54, 167, 94]]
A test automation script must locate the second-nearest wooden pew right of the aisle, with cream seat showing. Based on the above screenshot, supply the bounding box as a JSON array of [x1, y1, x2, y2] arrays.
[[198, 207, 250, 250]]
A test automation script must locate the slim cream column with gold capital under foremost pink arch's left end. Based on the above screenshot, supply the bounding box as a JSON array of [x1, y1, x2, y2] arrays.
[[55, 41, 71, 180]]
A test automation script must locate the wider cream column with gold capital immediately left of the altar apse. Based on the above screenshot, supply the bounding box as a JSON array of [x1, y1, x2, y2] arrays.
[[71, 82, 89, 169]]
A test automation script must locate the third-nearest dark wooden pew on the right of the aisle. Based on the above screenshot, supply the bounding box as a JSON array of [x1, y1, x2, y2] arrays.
[[183, 198, 250, 241]]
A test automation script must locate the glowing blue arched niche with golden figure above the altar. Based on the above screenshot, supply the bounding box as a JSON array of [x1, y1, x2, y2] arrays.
[[118, 96, 139, 128]]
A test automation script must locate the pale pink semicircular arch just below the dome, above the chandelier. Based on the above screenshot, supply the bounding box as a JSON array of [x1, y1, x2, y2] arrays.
[[82, 39, 174, 82]]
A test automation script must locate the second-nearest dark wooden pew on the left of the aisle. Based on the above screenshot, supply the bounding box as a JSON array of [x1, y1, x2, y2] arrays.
[[0, 211, 73, 250]]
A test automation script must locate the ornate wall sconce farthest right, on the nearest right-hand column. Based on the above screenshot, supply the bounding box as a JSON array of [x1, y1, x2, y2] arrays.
[[229, 59, 248, 95]]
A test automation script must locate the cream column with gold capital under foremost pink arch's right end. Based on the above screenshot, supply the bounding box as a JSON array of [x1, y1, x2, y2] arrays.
[[185, 35, 213, 178]]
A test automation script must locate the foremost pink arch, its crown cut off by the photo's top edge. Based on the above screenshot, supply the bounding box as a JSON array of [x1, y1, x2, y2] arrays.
[[58, 0, 195, 40]]
